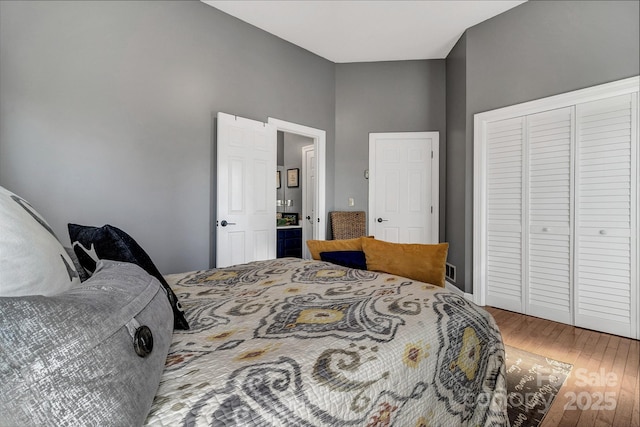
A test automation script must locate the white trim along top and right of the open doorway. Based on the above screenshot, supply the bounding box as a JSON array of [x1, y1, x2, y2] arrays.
[[267, 117, 327, 240]]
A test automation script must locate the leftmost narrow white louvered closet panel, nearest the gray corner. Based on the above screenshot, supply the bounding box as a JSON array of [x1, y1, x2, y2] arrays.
[[486, 118, 524, 312]]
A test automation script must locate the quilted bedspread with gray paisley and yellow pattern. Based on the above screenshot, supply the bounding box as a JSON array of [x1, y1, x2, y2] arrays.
[[146, 258, 507, 427]]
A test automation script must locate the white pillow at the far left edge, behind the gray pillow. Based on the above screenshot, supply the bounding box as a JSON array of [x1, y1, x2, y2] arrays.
[[0, 187, 80, 297]]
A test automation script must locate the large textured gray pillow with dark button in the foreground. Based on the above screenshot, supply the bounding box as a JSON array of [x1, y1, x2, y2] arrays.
[[0, 261, 173, 426]]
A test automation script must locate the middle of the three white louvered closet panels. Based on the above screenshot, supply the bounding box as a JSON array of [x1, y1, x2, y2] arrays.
[[525, 107, 573, 323]]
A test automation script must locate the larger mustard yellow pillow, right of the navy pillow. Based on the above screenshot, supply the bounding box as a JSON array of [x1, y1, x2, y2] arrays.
[[362, 239, 449, 287]]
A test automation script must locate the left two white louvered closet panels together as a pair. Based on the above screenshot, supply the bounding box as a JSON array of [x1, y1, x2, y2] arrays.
[[484, 107, 573, 323]]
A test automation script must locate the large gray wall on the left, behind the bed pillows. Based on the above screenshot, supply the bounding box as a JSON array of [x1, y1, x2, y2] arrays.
[[0, 1, 335, 273]]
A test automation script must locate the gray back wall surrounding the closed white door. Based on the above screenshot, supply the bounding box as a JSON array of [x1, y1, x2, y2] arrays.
[[334, 60, 446, 240]]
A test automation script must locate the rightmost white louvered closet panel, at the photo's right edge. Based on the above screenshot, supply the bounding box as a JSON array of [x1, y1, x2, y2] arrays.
[[575, 94, 638, 337]]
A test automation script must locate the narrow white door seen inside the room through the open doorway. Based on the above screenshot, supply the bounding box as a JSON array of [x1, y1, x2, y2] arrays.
[[301, 145, 316, 259]]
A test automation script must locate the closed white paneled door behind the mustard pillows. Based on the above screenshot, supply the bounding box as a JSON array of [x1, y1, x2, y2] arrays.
[[369, 132, 439, 243]]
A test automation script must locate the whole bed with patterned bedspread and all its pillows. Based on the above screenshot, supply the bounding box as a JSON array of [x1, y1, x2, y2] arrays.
[[0, 187, 507, 427]]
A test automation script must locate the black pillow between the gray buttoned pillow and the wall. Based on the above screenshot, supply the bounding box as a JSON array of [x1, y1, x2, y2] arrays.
[[68, 224, 189, 329]]
